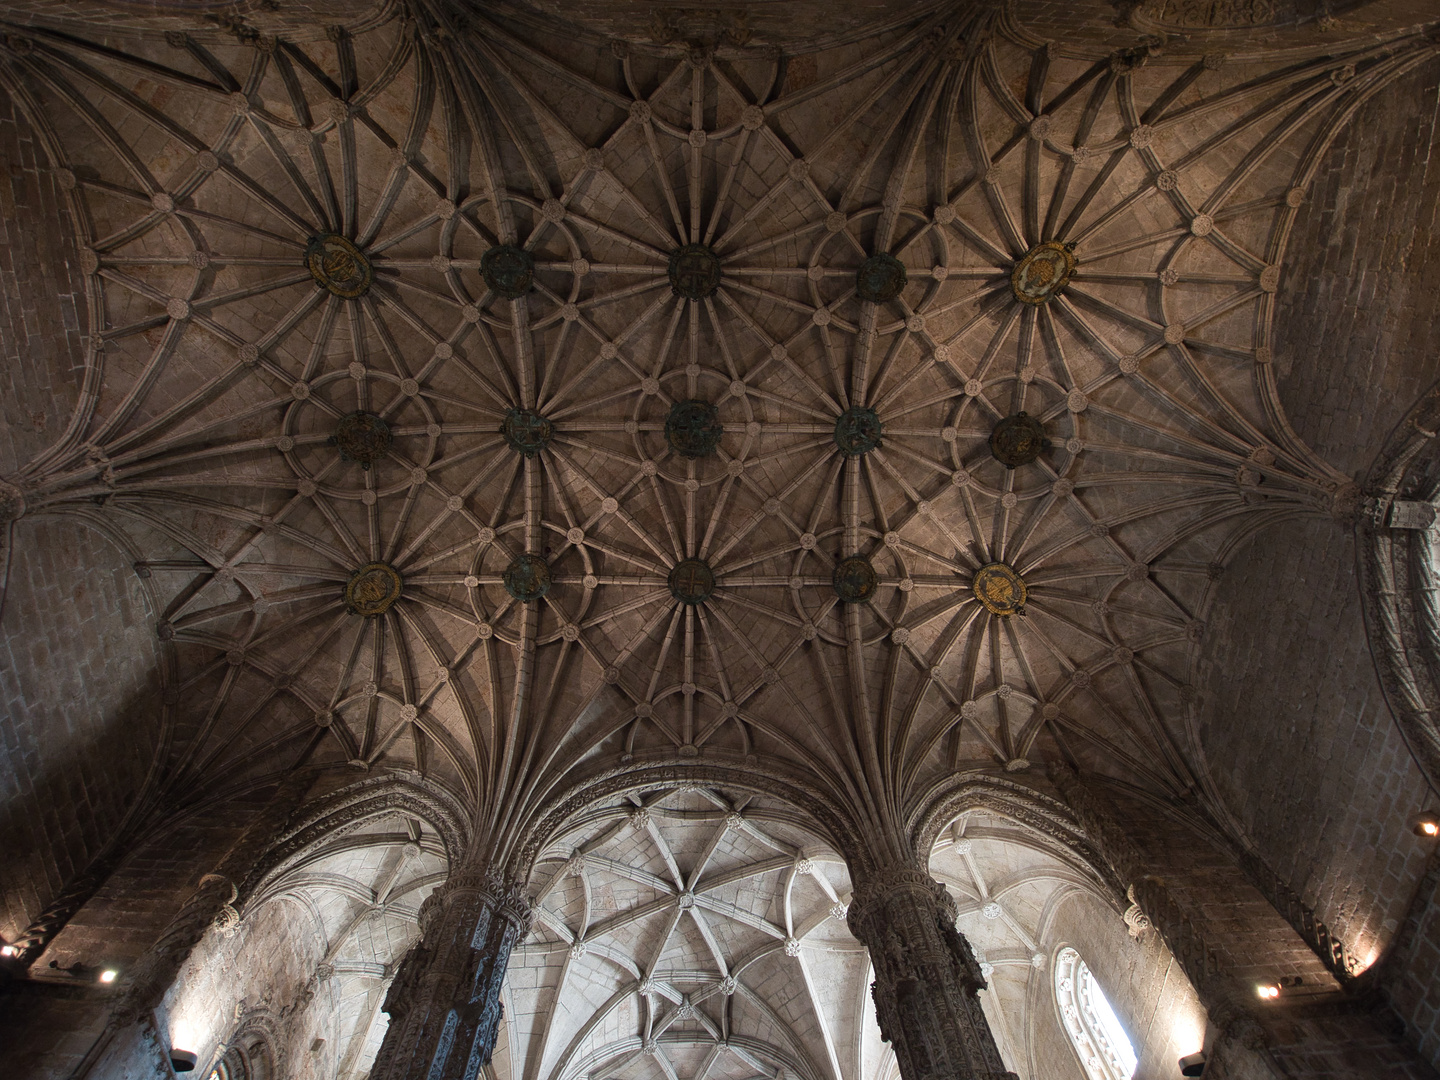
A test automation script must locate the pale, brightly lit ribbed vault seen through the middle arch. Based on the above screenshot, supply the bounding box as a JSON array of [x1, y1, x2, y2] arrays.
[[506, 788, 874, 1080]]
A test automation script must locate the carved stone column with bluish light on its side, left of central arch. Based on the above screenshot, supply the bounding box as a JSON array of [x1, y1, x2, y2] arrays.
[[370, 870, 533, 1080]]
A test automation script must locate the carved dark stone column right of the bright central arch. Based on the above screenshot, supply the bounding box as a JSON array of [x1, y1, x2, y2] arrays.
[[848, 865, 1015, 1080]]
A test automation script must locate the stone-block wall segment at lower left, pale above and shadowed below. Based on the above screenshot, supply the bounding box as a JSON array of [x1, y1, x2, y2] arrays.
[[0, 517, 161, 940]]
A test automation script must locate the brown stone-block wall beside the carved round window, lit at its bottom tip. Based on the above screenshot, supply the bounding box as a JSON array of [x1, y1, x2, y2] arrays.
[[1194, 520, 1427, 965]]
